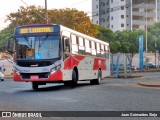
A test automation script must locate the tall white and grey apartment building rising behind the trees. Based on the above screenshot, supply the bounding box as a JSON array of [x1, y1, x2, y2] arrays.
[[92, 0, 160, 31]]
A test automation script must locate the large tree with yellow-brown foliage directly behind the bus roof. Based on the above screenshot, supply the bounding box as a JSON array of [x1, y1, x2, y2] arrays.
[[7, 6, 98, 37]]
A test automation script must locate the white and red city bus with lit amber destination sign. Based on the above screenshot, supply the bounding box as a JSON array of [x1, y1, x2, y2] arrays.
[[8, 24, 110, 89]]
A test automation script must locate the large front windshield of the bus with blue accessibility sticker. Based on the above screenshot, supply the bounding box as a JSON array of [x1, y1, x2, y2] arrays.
[[15, 35, 60, 60]]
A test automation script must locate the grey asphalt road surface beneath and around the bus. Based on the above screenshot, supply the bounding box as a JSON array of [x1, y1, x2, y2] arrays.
[[0, 72, 160, 120]]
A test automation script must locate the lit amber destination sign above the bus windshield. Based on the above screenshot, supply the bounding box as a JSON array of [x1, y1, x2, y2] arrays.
[[19, 27, 53, 34]]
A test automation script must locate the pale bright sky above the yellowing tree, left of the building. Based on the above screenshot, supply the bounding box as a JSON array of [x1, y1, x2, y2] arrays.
[[0, 0, 92, 30]]
